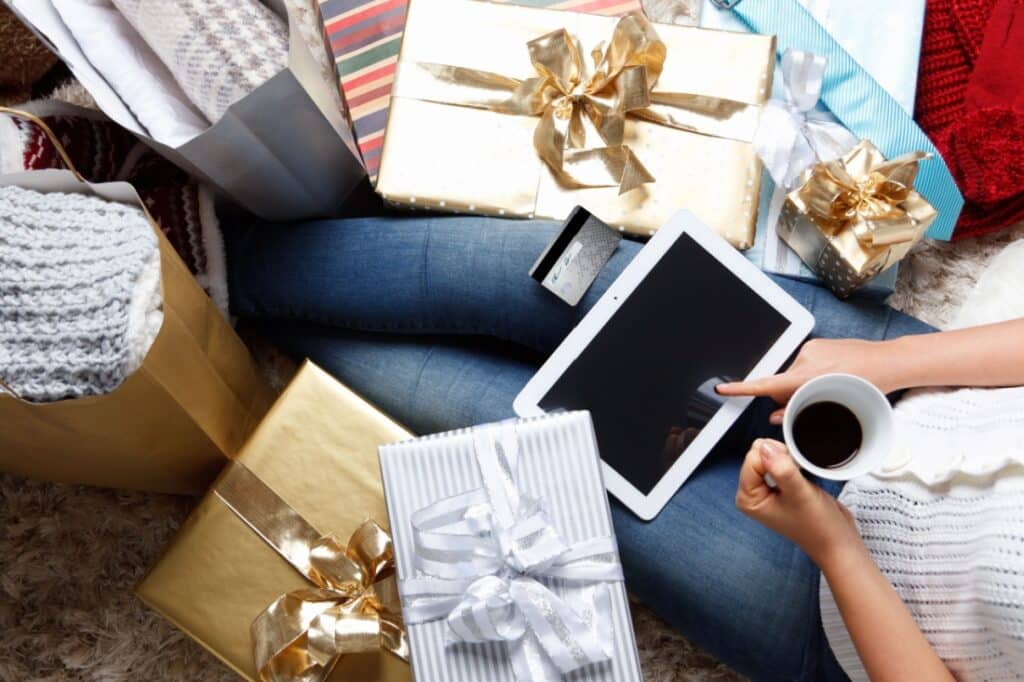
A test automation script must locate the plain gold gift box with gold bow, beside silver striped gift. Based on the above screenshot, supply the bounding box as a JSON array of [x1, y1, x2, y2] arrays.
[[136, 364, 412, 682]]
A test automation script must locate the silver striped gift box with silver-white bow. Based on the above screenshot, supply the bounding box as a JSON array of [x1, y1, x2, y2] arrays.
[[380, 412, 643, 682]]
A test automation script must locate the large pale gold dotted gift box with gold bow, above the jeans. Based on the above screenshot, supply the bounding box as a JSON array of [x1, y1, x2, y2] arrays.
[[377, 0, 775, 249]]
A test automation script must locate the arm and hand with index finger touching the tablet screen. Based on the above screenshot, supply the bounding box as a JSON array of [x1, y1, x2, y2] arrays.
[[718, 318, 1024, 423]]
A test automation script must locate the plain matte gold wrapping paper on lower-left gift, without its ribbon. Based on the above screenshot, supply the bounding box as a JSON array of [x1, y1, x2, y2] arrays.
[[136, 363, 412, 682]]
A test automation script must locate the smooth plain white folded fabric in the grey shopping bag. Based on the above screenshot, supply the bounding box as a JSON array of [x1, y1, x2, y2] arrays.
[[52, 0, 210, 146]]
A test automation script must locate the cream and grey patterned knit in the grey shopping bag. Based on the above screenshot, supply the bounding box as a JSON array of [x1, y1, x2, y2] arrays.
[[114, 0, 288, 123]]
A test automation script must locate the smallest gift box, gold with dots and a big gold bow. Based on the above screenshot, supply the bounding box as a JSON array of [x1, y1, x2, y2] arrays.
[[778, 140, 938, 298]]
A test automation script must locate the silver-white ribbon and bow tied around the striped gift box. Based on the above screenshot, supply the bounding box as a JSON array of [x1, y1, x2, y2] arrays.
[[400, 424, 623, 682]]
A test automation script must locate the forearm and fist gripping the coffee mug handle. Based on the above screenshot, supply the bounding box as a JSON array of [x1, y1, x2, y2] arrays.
[[736, 440, 953, 682]]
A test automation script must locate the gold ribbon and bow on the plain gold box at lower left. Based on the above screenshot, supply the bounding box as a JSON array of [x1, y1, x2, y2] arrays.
[[214, 462, 409, 682]]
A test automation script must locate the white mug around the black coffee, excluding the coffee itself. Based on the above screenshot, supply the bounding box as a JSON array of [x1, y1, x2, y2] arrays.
[[782, 374, 893, 480]]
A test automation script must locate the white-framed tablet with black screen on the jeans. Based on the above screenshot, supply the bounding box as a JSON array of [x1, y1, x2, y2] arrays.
[[514, 211, 814, 519]]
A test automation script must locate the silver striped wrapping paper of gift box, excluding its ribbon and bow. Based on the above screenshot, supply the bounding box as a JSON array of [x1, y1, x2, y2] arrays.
[[380, 412, 643, 682]]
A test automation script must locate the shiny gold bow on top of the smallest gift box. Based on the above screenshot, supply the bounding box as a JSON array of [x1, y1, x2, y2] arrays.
[[790, 140, 938, 249]]
